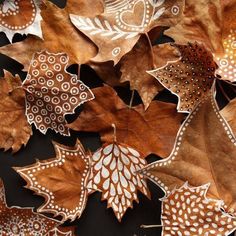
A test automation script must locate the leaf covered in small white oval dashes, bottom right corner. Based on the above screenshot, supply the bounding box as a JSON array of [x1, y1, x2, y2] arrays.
[[161, 184, 236, 236]]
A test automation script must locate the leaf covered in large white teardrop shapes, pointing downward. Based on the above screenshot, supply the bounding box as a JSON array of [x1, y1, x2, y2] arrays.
[[88, 143, 150, 221]]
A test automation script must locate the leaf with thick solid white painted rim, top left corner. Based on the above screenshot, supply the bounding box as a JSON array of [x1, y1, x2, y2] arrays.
[[0, 0, 42, 41]]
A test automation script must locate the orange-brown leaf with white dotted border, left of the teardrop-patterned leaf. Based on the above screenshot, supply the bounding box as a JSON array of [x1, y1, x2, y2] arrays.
[[15, 141, 90, 221]]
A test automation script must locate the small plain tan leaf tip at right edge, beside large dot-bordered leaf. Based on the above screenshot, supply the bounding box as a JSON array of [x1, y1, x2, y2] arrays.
[[220, 98, 236, 134]]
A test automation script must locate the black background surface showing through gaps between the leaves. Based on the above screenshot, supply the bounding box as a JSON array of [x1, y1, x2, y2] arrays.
[[0, 0, 233, 236]]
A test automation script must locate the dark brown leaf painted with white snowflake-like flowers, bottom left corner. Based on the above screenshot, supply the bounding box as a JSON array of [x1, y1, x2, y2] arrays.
[[0, 181, 60, 236]]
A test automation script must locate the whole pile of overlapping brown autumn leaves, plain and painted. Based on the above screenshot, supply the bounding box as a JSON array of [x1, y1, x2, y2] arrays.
[[0, 0, 236, 235]]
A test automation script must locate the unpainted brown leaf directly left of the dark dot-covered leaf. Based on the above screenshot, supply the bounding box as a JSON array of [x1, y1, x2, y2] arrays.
[[120, 37, 179, 109]]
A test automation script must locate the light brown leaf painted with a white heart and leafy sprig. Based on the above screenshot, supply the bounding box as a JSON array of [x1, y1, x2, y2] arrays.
[[70, 0, 183, 64]]
